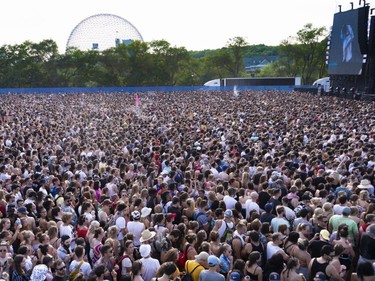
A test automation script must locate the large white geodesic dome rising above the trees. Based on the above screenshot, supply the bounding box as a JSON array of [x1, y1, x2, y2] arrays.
[[66, 14, 143, 51]]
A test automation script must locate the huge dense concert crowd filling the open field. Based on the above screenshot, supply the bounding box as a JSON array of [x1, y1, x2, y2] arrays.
[[0, 90, 375, 281]]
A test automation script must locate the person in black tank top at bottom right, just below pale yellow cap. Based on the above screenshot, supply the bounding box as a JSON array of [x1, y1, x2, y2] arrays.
[[309, 245, 345, 281]]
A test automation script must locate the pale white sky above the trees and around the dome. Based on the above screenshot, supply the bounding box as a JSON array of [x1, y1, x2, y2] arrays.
[[0, 0, 368, 53]]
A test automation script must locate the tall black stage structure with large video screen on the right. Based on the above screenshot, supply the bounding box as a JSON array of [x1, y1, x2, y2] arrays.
[[327, 1, 375, 100]]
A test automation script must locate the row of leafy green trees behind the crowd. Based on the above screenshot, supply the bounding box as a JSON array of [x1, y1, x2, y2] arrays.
[[0, 24, 327, 88]]
